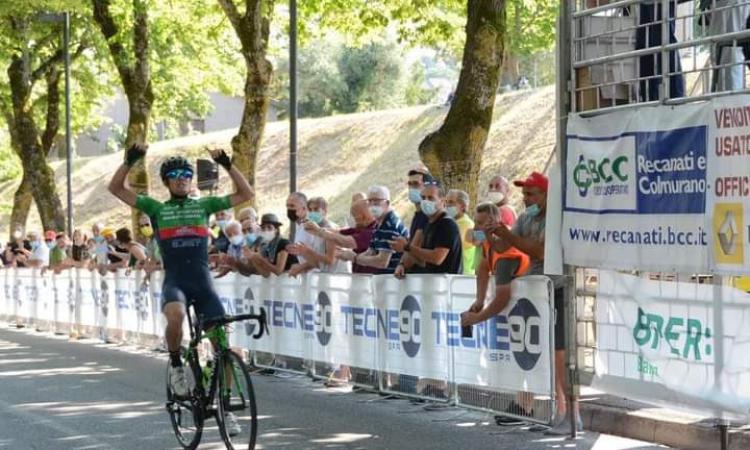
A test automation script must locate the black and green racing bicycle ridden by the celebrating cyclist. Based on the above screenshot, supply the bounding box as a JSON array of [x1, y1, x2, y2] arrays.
[[166, 308, 268, 450]]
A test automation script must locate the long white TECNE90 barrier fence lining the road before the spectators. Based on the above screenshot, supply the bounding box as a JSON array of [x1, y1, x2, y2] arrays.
[[0, 269, 555, 423]]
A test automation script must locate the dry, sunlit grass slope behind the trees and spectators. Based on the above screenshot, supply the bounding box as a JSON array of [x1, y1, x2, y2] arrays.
[[0, 86, 555, 236]]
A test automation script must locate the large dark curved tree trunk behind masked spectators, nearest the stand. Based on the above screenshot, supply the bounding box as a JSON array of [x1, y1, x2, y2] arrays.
[[419, 0, 505, 204]]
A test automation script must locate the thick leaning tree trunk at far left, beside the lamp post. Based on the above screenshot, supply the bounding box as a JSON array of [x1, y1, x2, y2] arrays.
[[8, 48, 65, 230]]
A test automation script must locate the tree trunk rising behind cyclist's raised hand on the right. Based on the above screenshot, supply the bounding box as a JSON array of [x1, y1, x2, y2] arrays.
[[218, 0, 273, 207]]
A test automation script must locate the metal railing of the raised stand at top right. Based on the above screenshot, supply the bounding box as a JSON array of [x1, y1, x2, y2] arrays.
[[563, 0, 750, 113]]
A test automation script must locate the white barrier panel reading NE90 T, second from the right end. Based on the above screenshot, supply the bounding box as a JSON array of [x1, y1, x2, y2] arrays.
[[373, 275, 452, 380]]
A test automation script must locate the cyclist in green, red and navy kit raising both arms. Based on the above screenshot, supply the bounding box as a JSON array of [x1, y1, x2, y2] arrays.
[[109, 144, 254, 404]]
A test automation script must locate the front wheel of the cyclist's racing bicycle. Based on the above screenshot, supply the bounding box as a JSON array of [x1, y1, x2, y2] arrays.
[[216, 351, 258, 450]]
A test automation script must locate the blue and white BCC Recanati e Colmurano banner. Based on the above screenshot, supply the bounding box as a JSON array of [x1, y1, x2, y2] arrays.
[[561, 104, 710, 272]]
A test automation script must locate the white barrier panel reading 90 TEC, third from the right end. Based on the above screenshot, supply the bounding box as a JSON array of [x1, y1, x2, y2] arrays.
[[303, 273, 382, 369]]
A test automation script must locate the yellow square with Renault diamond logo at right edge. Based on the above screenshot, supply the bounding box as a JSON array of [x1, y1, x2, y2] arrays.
[[713, 203, 745, 264]]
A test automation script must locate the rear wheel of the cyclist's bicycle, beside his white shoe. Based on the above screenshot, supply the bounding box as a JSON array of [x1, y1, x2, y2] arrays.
[[167, 352, 203, 450]]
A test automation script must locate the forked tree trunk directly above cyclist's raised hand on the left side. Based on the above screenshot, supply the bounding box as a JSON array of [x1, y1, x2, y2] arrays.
[[92, 0, 154, 239]]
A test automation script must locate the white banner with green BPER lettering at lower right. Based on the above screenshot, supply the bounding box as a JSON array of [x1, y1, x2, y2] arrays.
[[592, 270, 750, 416]]
